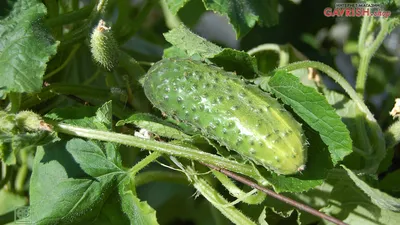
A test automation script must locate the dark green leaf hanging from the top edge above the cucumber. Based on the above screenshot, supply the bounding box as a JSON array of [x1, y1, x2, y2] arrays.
[[203, 0, 278, 38]]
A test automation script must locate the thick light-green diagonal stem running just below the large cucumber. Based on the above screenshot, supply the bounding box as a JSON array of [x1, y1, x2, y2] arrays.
[[52, 122, 258, 178]]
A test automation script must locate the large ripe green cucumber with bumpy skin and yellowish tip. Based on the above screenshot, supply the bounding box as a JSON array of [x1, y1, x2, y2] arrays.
[[144, 59, 307, 175]]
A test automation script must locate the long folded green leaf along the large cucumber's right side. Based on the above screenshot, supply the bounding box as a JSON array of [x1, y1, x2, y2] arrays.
[[269, 71, 352, 164]]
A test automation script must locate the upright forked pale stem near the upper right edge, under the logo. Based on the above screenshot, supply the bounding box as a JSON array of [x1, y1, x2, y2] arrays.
[[356, 19, 390, 97]]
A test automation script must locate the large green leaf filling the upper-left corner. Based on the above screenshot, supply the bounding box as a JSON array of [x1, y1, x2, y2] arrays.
[[0, 0, 58, 93]]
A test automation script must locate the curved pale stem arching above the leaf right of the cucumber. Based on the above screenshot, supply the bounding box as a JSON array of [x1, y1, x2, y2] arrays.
[[277, 61, 376, 122]]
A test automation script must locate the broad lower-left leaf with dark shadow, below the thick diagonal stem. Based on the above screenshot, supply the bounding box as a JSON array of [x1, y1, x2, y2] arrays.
[[30, 139, 157, 224]]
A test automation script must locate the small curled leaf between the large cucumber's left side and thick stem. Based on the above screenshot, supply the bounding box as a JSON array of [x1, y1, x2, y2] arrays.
[[116, 113, 190, 139]]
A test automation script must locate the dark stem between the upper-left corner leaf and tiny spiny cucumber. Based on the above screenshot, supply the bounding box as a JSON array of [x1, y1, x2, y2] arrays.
[[46, 2, 94, 27]]
